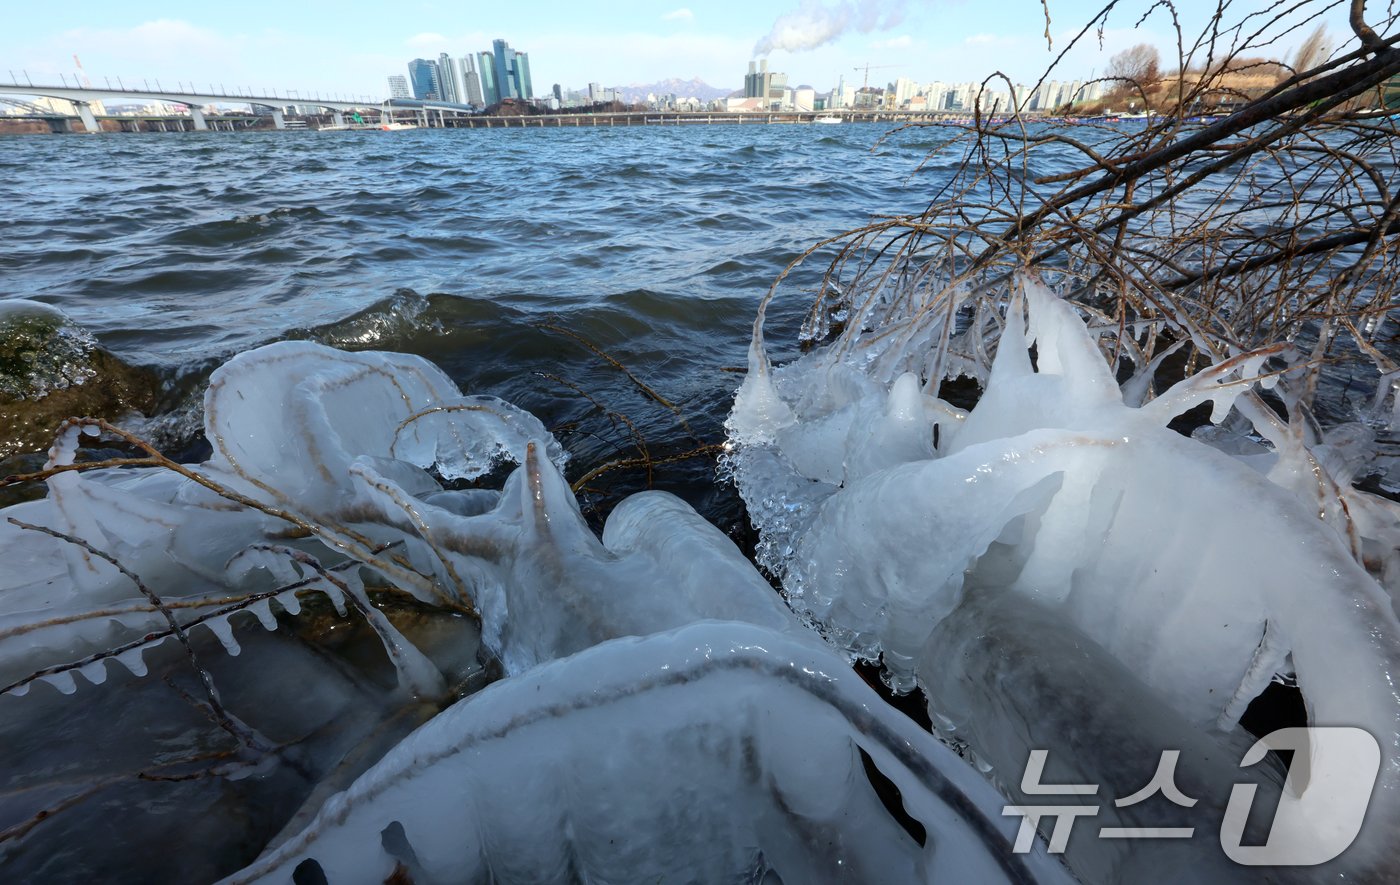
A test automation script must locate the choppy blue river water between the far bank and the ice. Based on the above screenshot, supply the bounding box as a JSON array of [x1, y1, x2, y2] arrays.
[[0, 125, 968, 520]]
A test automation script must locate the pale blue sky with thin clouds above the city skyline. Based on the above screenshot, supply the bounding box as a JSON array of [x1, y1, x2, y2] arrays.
[[8, 0, 1345, 97]]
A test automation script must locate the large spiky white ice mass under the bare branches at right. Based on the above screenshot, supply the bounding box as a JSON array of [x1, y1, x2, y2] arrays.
[[729, 274, 1400, 881]]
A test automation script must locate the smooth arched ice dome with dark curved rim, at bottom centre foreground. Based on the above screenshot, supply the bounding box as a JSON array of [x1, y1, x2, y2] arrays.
[[227, 622, 1068, 884]]
